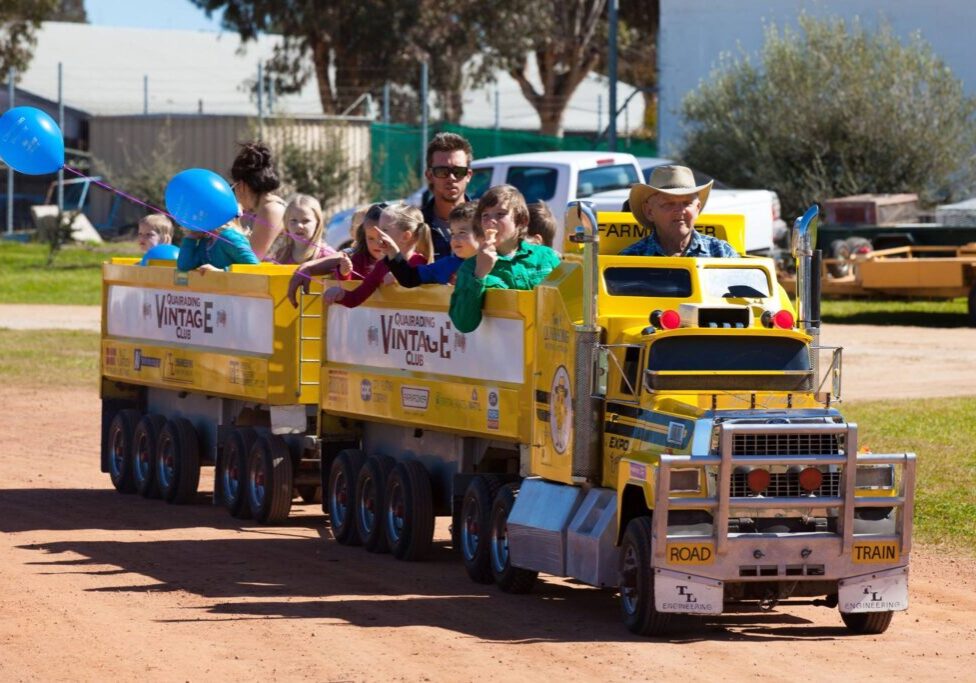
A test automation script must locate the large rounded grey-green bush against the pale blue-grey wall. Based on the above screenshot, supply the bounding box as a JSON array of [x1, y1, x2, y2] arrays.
[[682, 15, 976, 215]]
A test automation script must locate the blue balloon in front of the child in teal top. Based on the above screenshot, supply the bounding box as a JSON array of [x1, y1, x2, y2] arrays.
[[166, 168, 237, 231]]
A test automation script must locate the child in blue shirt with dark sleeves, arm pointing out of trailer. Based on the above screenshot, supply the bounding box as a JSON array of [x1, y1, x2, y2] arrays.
[[383, 202, 483, 287]]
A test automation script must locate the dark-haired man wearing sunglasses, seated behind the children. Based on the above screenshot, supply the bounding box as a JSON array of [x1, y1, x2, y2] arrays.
[[421, 133, 472, 258]]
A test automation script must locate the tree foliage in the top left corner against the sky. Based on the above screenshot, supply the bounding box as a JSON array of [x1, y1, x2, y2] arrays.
[[0, 0, 88, 80]]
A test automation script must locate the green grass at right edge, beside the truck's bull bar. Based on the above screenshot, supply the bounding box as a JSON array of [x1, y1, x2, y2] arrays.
[[843, 397, 976, 554]]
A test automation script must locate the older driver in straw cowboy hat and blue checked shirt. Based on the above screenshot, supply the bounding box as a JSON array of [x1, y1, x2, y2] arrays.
[[620, 166, 738, 258]]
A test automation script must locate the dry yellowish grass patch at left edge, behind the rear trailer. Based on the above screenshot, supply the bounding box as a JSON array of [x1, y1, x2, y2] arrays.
[[0, 329, 99, 388]]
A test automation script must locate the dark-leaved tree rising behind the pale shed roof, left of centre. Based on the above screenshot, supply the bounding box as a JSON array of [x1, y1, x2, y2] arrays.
[[191, 0, 417, 114]]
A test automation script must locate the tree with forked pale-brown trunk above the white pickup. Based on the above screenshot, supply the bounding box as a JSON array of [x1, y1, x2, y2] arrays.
[[491, 0, 606, 136]]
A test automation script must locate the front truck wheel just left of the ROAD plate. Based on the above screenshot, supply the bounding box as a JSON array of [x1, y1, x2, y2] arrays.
[[620, 516, 671, 636]]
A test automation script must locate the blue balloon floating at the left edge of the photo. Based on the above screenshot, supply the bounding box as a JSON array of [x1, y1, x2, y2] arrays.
[[0, 107, 64, 175]]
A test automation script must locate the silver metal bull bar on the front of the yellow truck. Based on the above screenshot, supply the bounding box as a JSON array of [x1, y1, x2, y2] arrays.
[[654, 423, 915, 560]]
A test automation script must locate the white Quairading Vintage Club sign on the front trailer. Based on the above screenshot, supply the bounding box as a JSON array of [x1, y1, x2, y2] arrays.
[[326, 306, 525, 382]]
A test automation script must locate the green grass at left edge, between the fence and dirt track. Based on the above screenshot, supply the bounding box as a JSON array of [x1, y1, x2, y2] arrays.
[[0, 242, 139, 305]]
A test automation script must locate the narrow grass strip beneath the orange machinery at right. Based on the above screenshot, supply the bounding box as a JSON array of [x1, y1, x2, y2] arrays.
[[820, 299, 974, 327]]
